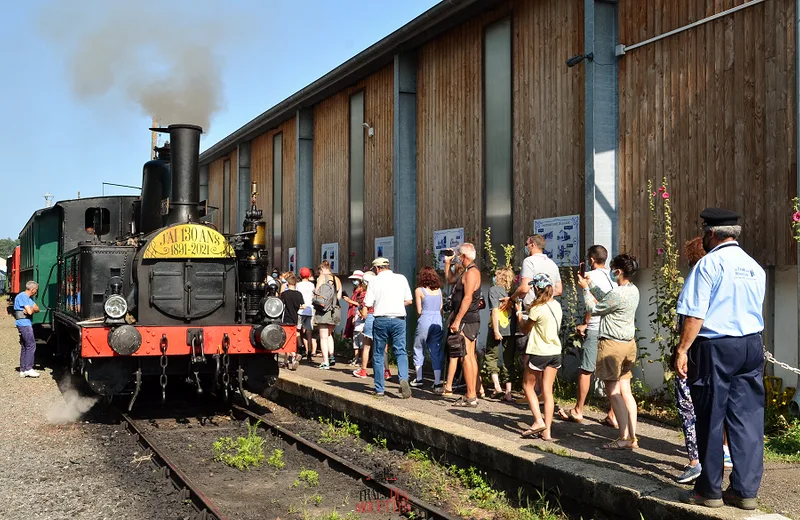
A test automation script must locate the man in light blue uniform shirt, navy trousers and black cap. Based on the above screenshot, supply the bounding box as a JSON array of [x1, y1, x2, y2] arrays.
[[675, 208, 766, 509]]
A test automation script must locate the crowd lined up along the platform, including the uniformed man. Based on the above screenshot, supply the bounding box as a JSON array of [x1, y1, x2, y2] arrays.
[[264, 208, 765, 509]]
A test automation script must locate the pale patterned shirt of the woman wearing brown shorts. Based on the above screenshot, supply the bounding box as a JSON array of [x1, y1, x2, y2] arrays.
[[586, 282, 639, 341]]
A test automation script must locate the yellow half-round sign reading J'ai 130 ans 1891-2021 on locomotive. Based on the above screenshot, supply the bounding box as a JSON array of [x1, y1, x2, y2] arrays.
[[144, 224, 235, 258]]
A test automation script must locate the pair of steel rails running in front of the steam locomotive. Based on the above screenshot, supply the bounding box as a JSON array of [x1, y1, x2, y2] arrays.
[[116, 398, 459, 520]]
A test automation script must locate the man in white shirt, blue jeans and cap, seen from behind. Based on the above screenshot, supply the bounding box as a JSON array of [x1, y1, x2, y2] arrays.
[[364, 258, 414, 399]]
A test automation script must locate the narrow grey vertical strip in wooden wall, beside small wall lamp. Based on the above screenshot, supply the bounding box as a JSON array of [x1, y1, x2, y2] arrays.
[[342, 90, 365, 269]]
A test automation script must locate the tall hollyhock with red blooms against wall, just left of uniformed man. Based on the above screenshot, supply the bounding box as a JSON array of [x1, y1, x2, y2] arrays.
[[647, 179, 683, 381]]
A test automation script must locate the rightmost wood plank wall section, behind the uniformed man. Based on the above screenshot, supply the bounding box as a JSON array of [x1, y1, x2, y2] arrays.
[[619, 0, 796, 265]]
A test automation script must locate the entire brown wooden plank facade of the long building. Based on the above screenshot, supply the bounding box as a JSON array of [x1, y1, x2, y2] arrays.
[[201, 0, 797, 272]]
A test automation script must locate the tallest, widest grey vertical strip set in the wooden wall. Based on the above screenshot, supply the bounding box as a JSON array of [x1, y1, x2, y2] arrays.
[[483, 18, 514, 252]]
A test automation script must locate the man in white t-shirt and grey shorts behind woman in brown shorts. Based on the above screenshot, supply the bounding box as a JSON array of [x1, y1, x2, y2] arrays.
[[558, 245, 617, 428]]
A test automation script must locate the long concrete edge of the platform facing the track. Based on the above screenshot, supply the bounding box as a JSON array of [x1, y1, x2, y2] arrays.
[[276, 372, 760, 520]]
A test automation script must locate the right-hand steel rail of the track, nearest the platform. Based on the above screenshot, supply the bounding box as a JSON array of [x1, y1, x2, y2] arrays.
[[231, 404, 460, 520]]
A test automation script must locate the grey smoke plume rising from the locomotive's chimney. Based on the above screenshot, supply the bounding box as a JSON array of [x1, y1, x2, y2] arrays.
[[40, 0, 236, 129]]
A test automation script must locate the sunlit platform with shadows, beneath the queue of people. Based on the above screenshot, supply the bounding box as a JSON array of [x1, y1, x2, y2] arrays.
[[278, 363, 800, 520]]
